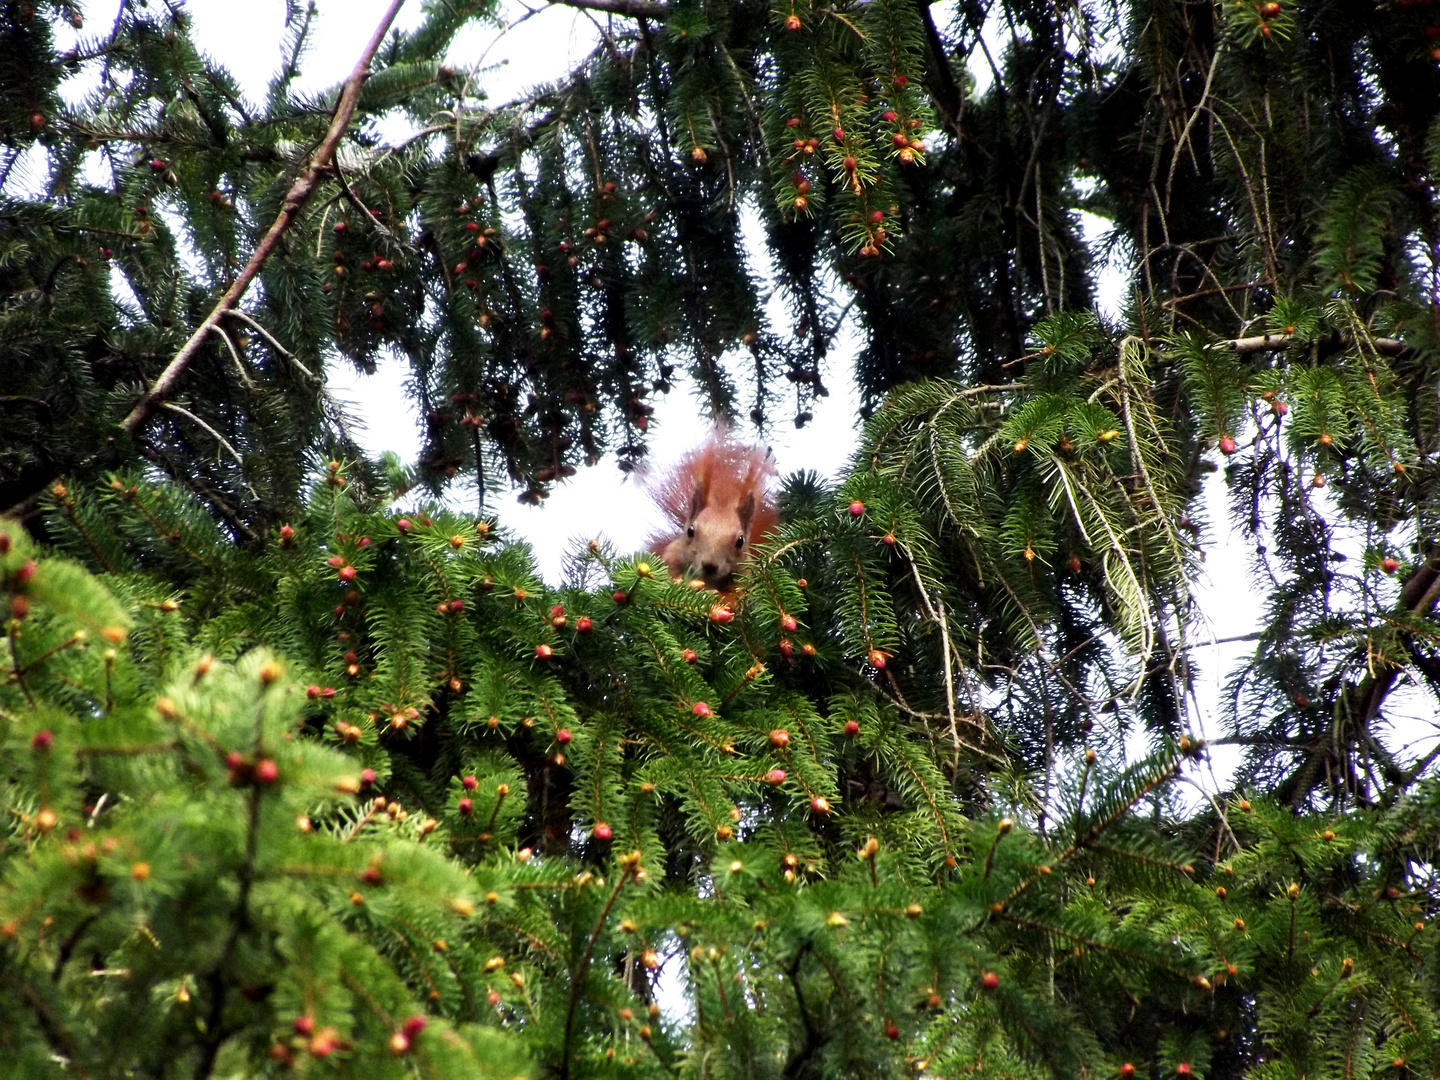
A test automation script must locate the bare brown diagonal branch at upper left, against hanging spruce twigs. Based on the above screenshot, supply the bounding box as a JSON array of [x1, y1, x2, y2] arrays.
[[120, 0, 405, 435]]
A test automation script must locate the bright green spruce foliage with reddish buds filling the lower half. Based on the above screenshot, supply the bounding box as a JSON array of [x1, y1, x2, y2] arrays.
[[8, 486, 1440, 1076]]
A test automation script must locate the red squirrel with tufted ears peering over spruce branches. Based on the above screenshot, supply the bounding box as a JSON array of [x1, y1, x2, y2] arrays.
[[645, 423, 779, 592]]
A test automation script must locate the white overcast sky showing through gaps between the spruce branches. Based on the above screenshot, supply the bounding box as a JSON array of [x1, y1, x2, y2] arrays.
[[50, 0, 1434, 788]]
